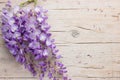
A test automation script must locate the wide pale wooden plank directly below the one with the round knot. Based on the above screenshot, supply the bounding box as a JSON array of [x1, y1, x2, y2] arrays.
[[0, 44, 120, 78]]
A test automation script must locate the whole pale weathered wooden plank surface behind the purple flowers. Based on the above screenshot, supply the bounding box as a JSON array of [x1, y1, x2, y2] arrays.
[[0, 0, 120, 80]]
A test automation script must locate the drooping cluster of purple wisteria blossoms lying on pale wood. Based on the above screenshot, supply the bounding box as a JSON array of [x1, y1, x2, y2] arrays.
[[1, 2, 70, 80]]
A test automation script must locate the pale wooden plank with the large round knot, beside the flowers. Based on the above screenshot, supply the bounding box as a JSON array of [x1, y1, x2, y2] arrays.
[[0, 0, 120, 43]]
